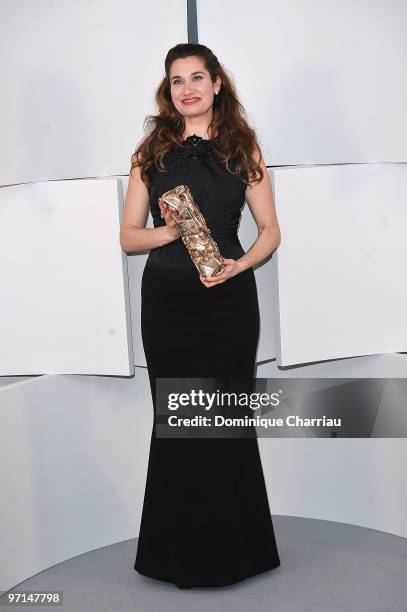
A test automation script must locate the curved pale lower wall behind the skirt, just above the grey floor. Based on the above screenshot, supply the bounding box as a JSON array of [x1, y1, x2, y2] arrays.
[[0, 372, 407, 591]]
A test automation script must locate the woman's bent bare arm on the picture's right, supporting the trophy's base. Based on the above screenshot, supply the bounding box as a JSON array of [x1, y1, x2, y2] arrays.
[[237, 152, 281, 272]]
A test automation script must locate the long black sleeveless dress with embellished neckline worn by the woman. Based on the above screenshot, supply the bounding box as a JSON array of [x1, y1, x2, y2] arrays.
[[134, 135, 280, 587]]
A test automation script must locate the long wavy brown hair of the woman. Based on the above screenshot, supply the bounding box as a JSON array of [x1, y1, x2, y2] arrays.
[[130, 43, 263, 187]]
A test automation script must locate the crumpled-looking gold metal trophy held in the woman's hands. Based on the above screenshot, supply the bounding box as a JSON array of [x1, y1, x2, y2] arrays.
[[161, 185, 225, 277]]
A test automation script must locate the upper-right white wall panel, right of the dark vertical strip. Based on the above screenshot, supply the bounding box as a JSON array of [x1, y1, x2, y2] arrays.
[[197, 0, 407, 165]]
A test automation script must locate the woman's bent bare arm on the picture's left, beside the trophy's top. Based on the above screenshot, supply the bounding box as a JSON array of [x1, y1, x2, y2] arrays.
[[120, 166, 180, 253]]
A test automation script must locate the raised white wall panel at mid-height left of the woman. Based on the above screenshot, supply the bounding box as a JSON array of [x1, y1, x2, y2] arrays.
[[0, 179, 134, 376]]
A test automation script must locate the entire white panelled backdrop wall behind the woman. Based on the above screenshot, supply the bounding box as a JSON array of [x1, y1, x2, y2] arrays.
[[0, 0, 407, 590]]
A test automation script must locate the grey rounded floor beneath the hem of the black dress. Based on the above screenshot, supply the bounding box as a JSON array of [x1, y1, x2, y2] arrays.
[[3, 515, 407, 612]]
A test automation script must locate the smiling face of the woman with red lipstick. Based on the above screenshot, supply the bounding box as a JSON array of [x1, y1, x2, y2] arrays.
[[170, 56, 221, 117]]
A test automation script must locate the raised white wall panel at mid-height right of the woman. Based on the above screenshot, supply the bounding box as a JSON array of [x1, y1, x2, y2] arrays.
[[271, 164, 407, 366]]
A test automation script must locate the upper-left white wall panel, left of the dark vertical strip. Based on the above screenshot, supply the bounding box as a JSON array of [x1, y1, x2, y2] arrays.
[[0, 0, 187, 185]]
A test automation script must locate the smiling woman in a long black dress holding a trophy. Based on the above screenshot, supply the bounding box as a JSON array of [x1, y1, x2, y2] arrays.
[[120, 44, 280, 588]]
